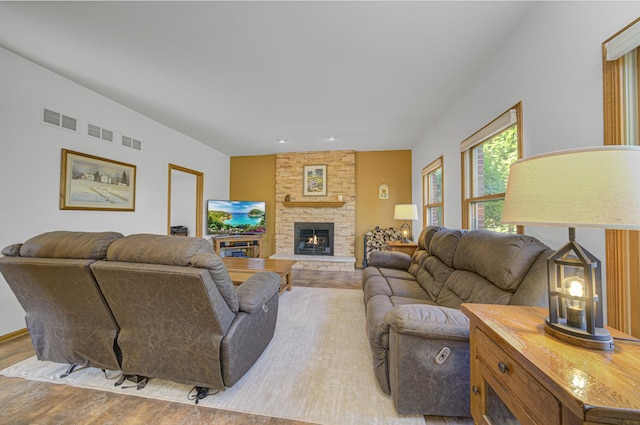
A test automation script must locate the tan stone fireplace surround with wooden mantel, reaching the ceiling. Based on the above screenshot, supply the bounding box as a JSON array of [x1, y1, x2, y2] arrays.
[[271, 151, 356, 271]]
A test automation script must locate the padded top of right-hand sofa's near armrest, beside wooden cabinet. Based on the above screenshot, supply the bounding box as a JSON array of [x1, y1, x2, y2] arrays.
[[384, 304, 469, 341]]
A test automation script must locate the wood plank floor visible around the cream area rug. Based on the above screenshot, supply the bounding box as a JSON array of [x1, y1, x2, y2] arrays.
[[0, 270, 472, 425]]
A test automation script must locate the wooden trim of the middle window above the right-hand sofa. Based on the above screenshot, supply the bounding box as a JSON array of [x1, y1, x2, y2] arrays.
[[460, 101, 524, 234]]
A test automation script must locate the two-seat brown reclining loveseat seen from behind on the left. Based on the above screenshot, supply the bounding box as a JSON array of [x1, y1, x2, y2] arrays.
[[0, 231, 280, 390]]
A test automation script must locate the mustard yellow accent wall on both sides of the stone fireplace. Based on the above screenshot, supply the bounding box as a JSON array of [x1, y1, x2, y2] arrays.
[[229, 150, 412, 267]]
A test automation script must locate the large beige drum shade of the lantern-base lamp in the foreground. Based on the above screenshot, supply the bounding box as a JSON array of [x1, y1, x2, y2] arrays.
[[502, 146, 640, 229]]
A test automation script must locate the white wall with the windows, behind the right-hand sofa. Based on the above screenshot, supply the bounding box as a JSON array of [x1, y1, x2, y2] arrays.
[[412, 1, 640, 268]]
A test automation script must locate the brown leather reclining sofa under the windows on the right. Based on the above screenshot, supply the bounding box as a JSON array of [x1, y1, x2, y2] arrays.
[[362, 227, 553, 417]]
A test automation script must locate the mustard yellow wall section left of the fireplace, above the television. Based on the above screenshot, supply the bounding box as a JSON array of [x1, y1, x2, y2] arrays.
[[229, 155, 276, 258]]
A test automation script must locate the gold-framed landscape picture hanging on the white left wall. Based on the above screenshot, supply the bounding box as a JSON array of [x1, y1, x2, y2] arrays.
[[60, 149, 136, 211]]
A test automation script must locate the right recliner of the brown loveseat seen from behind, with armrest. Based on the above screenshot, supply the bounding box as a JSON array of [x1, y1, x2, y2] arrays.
[[91, 234, 280, 389]]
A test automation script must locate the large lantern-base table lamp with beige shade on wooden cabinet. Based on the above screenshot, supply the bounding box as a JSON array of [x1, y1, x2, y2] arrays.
[[502, 146, 640, 350]]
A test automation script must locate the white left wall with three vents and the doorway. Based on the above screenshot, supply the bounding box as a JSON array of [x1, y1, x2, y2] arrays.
[[0, 49, 229, 335]]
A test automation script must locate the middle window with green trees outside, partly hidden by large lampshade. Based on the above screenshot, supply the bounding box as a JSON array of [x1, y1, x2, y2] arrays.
[[460, 103, 523, 233]]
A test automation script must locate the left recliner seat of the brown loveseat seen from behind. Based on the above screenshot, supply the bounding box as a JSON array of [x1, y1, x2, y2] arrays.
[[0, 231, 123, 372]]
